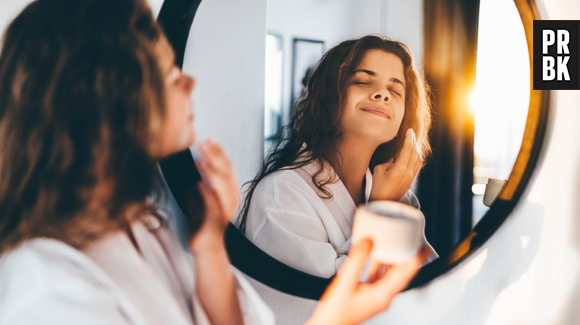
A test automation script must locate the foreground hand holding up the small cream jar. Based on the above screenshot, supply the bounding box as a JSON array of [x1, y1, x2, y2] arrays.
[[307, 239, 429, 325]]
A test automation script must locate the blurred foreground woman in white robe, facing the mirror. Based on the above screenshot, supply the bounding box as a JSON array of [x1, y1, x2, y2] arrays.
[[0, 0, 423, 324]]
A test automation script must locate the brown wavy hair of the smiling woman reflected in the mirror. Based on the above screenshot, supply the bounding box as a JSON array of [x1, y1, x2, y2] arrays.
[[239, 35, 431, 233]]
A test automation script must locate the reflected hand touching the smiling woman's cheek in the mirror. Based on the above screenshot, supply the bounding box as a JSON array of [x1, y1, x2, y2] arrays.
[[369, 129, 423, 201]]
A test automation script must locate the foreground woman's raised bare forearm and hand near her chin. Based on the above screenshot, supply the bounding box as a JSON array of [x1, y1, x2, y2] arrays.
[[190, 141, 243, 325]]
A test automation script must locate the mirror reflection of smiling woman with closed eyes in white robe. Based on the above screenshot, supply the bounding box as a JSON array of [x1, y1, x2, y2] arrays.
[[239, 36, 437, 278]]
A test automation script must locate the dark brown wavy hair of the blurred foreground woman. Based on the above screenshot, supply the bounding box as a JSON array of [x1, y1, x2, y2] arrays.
[[0, 0, 164, 252]]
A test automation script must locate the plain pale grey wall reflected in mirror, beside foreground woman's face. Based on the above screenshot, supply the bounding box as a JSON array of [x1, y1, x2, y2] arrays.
[[183, 0, 266, 183]]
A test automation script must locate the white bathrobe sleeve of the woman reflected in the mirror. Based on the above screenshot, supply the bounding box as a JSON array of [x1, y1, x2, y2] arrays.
[[246, 170, 349, 278]]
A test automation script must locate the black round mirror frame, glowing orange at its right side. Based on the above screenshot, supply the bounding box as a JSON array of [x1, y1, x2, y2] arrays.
[[158, 0, 550, 299]]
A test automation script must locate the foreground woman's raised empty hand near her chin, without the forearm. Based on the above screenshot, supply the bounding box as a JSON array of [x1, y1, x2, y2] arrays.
[[190, 140, 239, 253]]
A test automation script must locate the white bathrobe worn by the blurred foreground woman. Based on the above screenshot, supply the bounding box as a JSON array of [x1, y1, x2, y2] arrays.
[[0, 217, 274, 325]]
